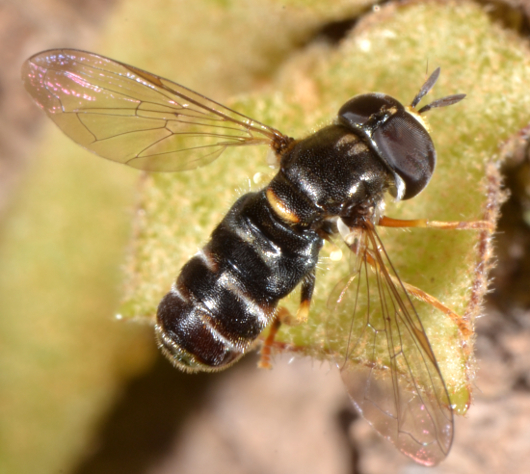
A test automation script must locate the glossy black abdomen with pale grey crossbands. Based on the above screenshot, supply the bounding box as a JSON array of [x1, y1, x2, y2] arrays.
[[156, 190, 322, 371]]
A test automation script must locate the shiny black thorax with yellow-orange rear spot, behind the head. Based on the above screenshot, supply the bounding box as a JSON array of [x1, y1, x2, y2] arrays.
[[266, 125, 393, 227]]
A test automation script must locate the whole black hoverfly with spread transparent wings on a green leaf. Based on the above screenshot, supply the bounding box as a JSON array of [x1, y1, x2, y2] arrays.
[[22, 49, 472, 465]]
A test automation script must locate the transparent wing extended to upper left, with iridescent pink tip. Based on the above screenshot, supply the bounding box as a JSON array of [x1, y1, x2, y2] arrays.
[[22, 49, 291, 171]]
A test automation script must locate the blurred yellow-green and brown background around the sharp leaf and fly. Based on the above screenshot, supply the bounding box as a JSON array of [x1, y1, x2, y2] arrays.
[[0, 0, 530, 474]]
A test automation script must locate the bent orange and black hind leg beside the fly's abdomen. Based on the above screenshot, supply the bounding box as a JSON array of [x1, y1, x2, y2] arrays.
[[258, 270, 315, 369]]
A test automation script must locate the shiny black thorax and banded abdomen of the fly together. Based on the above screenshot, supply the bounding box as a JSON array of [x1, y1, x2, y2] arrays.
[[157, 124, 393, 369]]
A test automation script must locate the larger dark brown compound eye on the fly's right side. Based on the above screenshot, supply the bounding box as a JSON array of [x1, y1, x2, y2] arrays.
[[372, 111, 436, 199]]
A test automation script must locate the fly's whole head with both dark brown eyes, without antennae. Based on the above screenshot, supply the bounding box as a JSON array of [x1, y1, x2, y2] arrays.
[[339, 94, 436, 199]]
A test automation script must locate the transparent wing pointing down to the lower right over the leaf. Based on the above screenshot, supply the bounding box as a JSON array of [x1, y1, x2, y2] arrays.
[[328, 218, 453, 466]]
